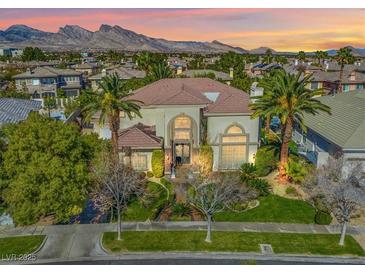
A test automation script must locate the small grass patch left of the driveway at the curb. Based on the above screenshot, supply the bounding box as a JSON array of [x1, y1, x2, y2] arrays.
[[0, 235, 45, 258]]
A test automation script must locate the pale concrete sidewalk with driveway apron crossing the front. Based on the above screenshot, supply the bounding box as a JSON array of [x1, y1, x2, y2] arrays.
[[0, 222, 365, 260]]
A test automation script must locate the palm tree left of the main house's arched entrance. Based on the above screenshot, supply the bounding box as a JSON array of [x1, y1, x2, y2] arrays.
[[82, 73, 142, 160]]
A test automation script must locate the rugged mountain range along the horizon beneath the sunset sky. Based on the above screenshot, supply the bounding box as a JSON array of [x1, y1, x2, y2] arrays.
[[0, 24, 365, 56]]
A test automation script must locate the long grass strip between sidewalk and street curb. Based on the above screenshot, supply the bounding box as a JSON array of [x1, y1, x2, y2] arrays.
[[103, 231, 365, 256]]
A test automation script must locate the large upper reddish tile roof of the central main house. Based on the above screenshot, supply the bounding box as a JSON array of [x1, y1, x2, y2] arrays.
[[131, 78, 251, 113]]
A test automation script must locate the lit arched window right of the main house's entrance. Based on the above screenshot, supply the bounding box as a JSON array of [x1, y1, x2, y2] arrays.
[[220, 125, 248, 169]]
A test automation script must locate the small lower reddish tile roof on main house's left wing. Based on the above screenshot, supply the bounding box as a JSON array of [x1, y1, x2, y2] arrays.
[[118, 123, 162, 149]]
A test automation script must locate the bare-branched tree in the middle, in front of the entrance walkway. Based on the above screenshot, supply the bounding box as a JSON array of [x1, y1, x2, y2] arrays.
[[188, 173, 257, 243]]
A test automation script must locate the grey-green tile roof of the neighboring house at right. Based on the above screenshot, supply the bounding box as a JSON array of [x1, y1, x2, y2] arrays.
[[304, 89, 365, 150]]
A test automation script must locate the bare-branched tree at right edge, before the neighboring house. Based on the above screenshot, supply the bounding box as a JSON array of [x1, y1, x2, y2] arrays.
[[305, 157, 365, 245]]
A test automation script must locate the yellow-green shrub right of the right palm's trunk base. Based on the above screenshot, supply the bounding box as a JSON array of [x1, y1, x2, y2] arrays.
[[285, 155, 313, 183]]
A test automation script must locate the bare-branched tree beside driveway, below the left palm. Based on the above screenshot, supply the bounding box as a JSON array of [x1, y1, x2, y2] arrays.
[[93, 153, 144, 240]]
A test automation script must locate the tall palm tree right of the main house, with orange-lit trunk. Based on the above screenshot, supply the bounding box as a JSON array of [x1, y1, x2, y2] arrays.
[[250, 70, 330, 182]]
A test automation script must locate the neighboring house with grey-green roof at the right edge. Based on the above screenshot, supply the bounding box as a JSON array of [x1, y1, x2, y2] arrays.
[[293, 90, 365, 166]]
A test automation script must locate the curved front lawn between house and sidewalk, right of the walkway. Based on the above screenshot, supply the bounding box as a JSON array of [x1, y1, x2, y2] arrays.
[[214, 195, 328, 224]]
